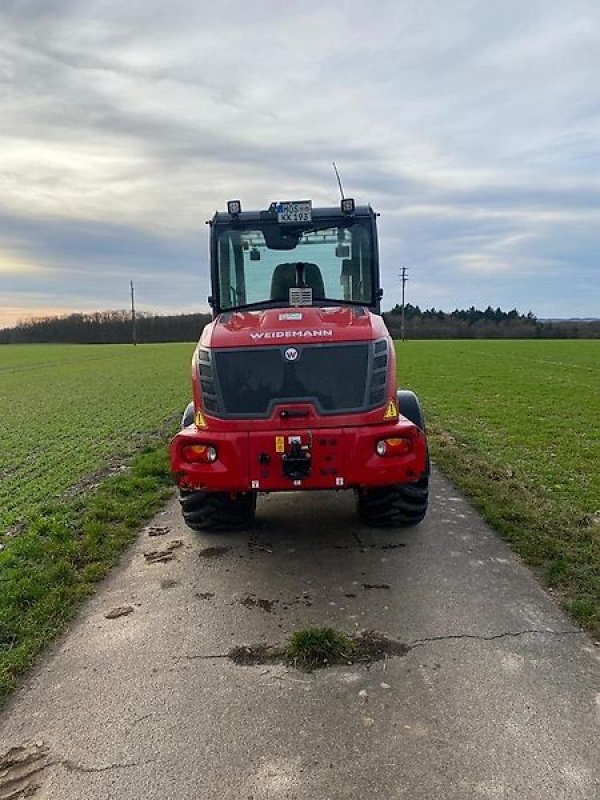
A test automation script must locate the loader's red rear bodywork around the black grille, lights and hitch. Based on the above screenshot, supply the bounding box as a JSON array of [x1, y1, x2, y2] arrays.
[[170, 307, 428, 492]]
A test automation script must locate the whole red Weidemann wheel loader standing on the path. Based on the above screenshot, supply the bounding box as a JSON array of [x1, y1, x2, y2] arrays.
[[170, 198, 429, 530]]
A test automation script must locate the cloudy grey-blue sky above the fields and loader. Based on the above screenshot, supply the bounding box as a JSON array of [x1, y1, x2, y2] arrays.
[[0, 0, 600, 327]]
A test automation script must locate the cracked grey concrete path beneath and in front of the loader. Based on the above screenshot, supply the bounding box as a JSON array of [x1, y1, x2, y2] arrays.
[[0, 474, 600, 800]]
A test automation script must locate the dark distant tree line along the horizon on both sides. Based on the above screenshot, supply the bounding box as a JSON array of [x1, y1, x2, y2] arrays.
[[0, 303, 600, 344]]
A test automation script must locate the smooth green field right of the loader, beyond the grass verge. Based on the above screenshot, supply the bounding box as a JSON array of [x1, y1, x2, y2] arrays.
[[396, 340, 600, 516]]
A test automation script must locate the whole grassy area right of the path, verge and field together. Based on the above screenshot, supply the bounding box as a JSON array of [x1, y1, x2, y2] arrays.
[[397, 340, 600, 637]]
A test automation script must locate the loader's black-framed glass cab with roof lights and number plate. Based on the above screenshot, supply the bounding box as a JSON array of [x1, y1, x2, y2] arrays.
[[209, 199, 382, 314]]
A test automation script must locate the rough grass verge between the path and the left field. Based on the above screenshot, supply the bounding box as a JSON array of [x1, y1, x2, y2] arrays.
[[0, 439, 171, 705]]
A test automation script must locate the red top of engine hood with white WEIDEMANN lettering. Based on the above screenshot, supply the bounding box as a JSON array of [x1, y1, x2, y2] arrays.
[[201, 306, 388, 349]]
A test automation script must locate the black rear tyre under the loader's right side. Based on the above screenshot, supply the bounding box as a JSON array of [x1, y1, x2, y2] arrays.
[[358, 475, 429, 528]]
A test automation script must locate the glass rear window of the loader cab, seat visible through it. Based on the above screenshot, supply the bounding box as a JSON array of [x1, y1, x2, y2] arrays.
[[217, 219, 374, 309]]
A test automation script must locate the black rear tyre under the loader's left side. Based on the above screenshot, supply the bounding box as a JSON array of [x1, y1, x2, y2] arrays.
[[179, 489, 256, 531]]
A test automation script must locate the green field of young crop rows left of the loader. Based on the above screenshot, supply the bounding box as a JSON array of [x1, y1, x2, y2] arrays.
[[0, 344, 193, 534]]
